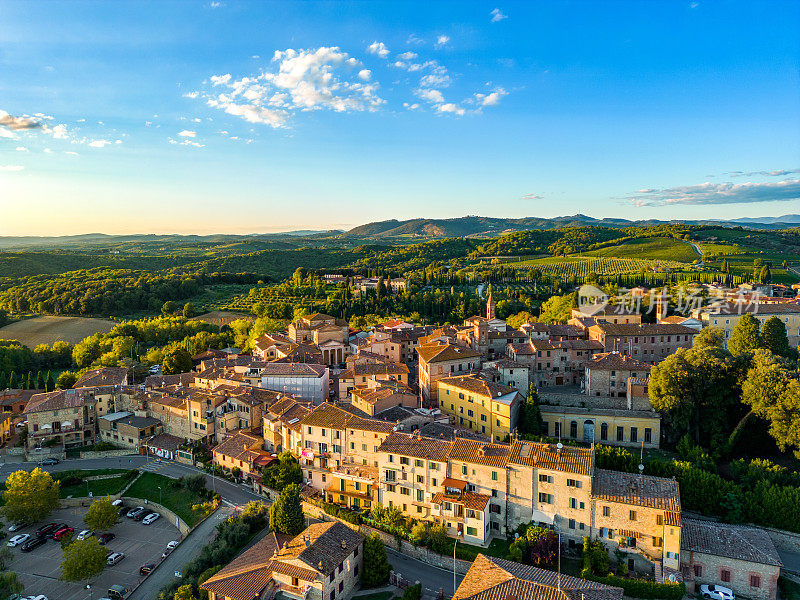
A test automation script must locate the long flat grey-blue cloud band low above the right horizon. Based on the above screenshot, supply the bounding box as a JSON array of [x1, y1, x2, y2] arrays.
[[625, 179, 800, 206]]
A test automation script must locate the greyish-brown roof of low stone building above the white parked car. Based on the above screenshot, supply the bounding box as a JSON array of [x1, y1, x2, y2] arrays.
[[681, 519, 783, 567]]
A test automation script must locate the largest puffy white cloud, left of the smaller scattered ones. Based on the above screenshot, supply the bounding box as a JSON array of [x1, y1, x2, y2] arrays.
[[203, 42, 385, 127]]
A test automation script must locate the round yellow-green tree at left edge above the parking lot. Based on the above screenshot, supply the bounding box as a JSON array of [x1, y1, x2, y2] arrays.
[[2, 467, 59, 523]]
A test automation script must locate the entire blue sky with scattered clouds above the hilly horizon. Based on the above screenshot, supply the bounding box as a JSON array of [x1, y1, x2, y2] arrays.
[[0, 0, 800, 235]]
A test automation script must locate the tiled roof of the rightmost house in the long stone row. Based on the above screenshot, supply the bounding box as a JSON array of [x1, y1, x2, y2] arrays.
[[592, 469, 681, 513]]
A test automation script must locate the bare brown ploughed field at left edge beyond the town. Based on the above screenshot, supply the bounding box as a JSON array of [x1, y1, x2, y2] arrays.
[[0, 317, 116, 349]]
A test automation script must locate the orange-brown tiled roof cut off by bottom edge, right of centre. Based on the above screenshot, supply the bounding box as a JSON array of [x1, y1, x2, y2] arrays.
[[453, 554, 623, 600]]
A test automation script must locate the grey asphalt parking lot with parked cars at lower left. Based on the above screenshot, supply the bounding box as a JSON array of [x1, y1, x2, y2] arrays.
[[4, 507, 181, 600]]
